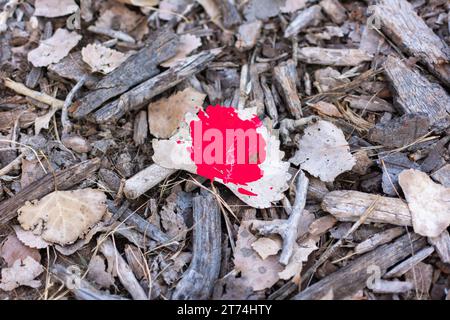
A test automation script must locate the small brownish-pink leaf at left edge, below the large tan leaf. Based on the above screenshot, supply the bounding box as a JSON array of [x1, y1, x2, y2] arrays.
[[0, 233, 41, 267]]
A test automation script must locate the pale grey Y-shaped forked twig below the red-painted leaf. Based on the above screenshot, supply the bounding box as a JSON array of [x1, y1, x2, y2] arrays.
[[253, 170, 309, 265]]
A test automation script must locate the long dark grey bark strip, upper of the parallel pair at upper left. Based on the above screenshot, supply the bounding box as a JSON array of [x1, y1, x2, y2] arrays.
[[71, 31, 178, 119]]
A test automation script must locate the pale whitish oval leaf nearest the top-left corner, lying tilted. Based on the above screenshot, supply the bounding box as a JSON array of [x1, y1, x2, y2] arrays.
[[28, 29, 81, 67]]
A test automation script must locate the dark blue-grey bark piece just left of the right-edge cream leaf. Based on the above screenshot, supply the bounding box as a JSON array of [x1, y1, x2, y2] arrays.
[[379, 152, 419, 196]]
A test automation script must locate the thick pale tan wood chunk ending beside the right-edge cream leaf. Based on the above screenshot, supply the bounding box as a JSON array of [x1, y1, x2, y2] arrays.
[[322, 190, 412, 226]]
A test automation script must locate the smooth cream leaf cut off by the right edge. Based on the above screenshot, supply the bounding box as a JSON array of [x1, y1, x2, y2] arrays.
[[398, 169, 450, 237]]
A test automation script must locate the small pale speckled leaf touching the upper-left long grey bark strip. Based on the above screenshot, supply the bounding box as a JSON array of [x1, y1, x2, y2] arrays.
[[81, 44, 127, 74]]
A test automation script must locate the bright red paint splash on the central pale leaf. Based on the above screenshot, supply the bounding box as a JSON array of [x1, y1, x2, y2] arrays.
[[189, 105, 266, 196]]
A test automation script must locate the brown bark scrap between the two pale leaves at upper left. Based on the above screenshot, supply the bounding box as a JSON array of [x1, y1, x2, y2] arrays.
[[47, 51, 99, 89]]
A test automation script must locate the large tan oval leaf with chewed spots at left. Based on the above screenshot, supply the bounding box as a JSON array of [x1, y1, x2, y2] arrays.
[[18, 188, 106, 245]]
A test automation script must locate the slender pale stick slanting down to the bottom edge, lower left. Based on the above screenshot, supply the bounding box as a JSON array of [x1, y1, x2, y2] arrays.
[[99, 239, 148, 300]]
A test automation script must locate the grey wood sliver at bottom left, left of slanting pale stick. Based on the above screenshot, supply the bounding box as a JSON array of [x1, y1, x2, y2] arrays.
[[50, 264, 128, 300]]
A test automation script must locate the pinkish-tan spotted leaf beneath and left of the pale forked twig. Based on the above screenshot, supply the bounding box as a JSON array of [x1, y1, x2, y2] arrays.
[[234, 220, 283, 291]]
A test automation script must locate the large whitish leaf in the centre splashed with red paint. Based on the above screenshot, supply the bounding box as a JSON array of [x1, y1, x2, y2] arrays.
[[153, 106, 290, 208]]
